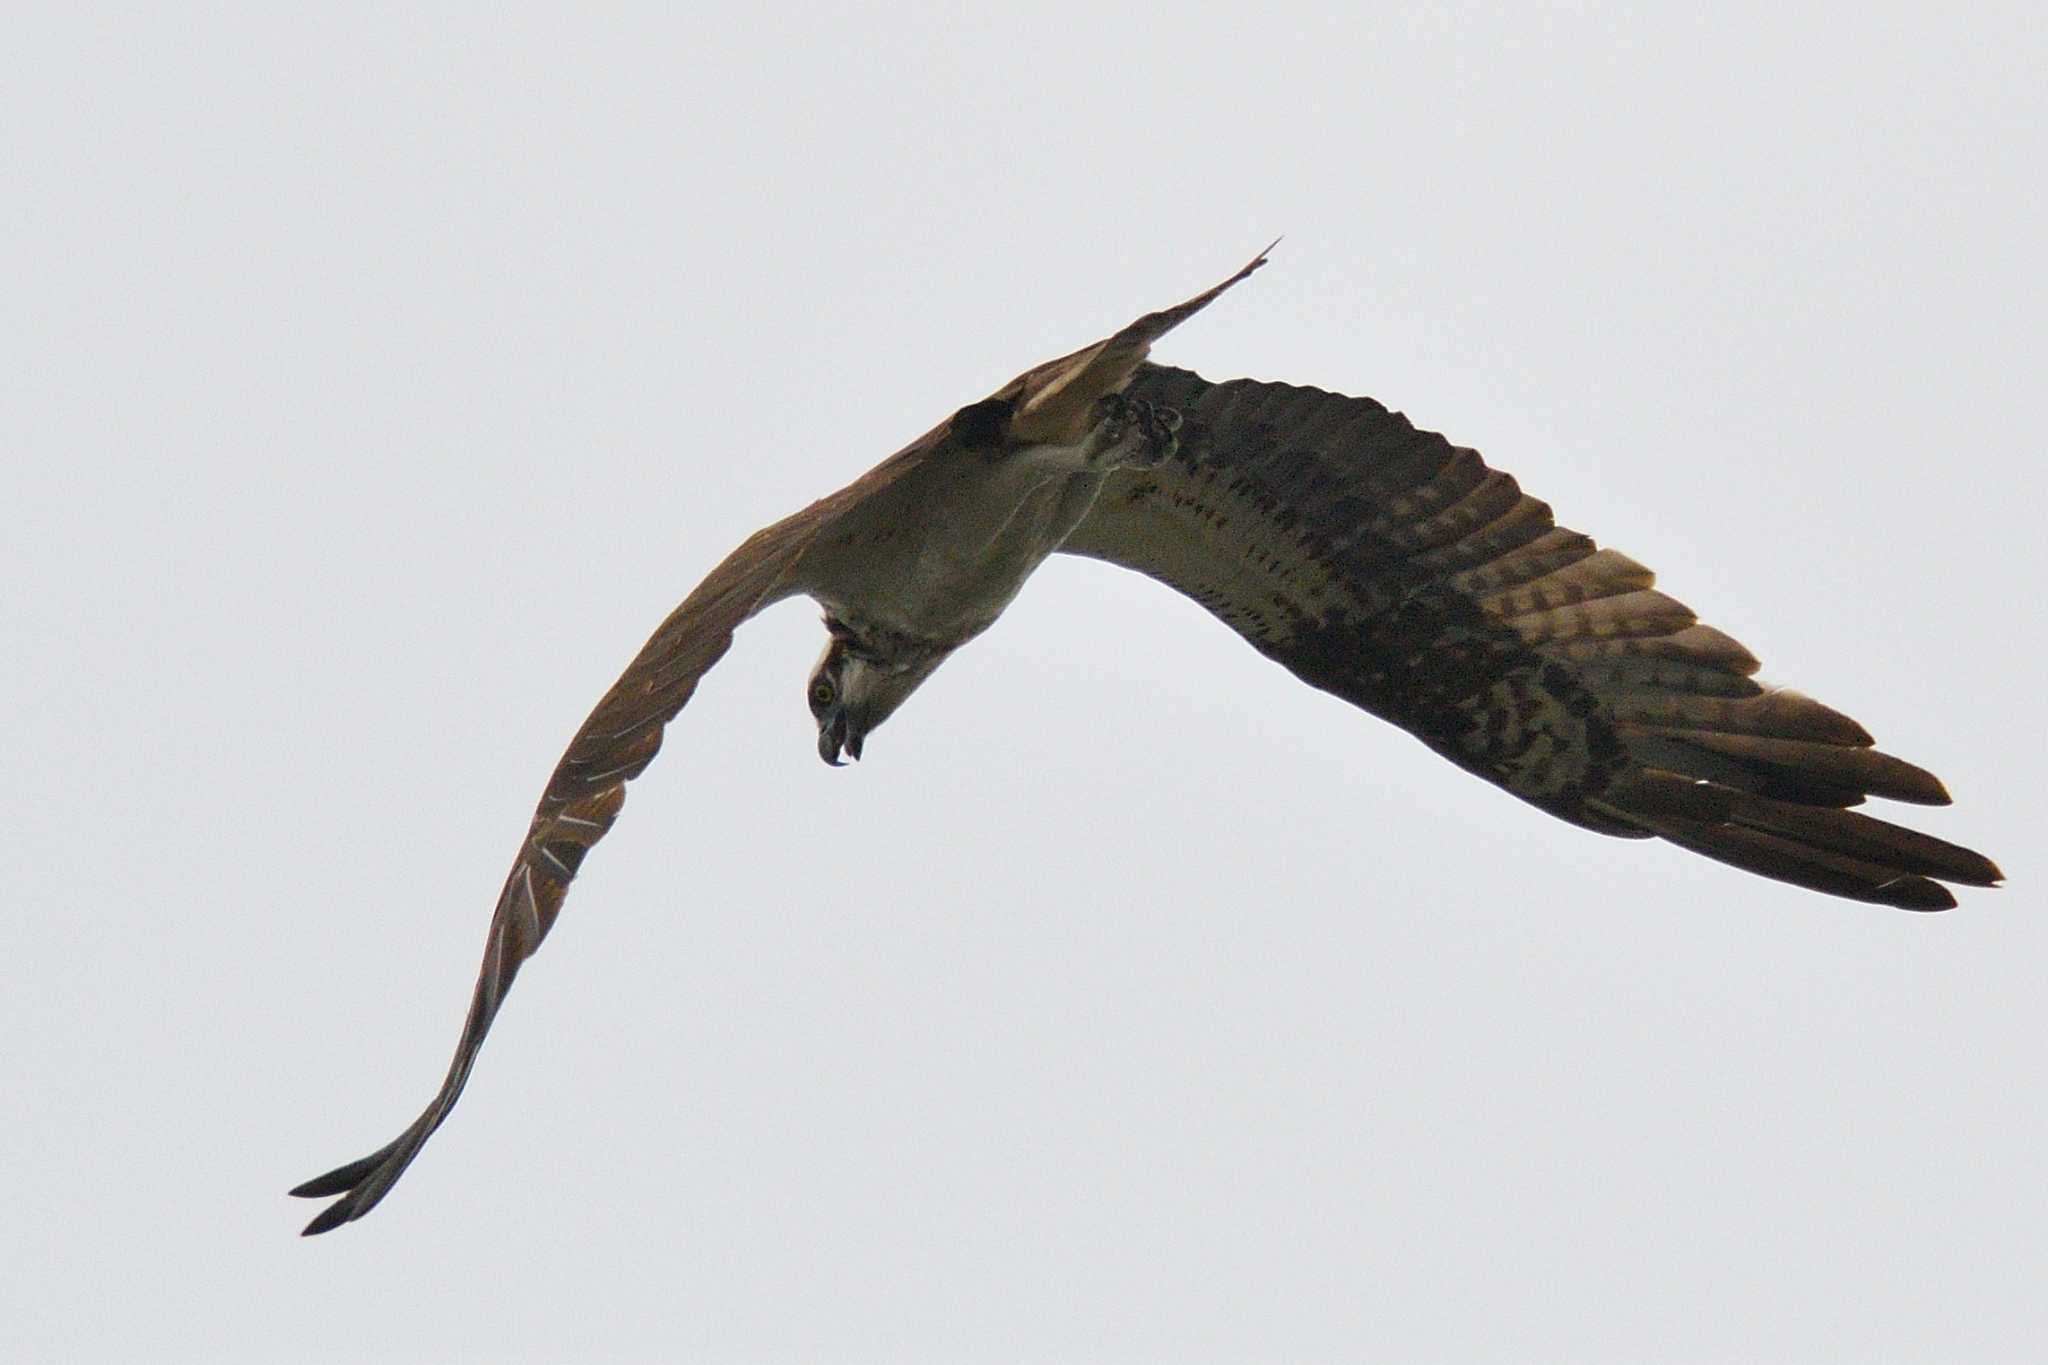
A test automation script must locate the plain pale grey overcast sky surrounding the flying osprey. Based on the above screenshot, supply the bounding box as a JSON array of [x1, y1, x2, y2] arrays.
[[0, 4, 2048, 1361]]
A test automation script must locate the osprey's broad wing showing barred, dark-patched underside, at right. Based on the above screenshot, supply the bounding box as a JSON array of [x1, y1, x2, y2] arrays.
[[1063, 364, 2001, 911]]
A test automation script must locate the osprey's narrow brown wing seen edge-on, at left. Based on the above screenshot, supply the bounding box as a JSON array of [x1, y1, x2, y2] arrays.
[[291, 444, 944, 1236]]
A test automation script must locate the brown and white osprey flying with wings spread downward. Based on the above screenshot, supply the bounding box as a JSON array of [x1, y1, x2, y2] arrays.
[[291, 248, 2001, 1234]]
